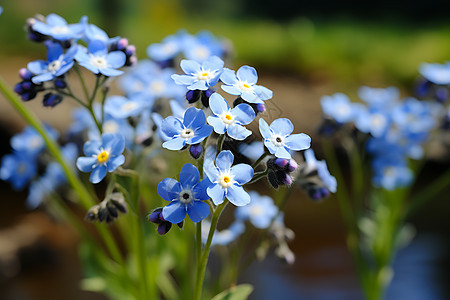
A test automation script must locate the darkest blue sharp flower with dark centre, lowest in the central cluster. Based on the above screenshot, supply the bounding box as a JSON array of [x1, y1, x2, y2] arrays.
[[158, 164, 211, 224]]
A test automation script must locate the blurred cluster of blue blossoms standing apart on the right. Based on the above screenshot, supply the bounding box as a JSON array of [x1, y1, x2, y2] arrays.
[[321, 83, 443, 190]]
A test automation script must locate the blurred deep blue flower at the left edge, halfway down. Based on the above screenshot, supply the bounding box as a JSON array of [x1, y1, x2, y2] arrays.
[[0, 151, 37, 190]]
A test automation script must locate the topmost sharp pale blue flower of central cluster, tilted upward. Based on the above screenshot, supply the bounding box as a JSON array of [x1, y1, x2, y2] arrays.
[[172, 56, 224, 91]]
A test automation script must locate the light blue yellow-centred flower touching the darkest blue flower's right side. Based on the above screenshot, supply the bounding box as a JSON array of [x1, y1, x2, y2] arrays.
[[205, 150, 254, 206]]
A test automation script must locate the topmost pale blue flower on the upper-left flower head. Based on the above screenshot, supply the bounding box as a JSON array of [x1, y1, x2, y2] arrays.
[[32, 14, 84, 41]]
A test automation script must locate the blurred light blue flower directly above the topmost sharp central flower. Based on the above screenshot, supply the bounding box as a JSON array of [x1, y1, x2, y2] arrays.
[[181, 31, 225, 63]]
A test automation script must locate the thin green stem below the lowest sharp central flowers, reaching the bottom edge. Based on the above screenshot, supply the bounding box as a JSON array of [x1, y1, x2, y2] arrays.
[[193, 200, 228, 300]]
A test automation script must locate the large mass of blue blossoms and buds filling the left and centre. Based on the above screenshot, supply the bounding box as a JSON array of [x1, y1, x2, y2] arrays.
[[1, 14, 336, 261]]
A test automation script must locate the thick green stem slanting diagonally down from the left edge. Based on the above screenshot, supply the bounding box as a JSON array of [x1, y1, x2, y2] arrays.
[[0, 78, 123, 263]]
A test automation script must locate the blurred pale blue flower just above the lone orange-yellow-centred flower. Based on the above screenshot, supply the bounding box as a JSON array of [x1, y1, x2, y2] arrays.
[[104, 96, 146, 119]]
